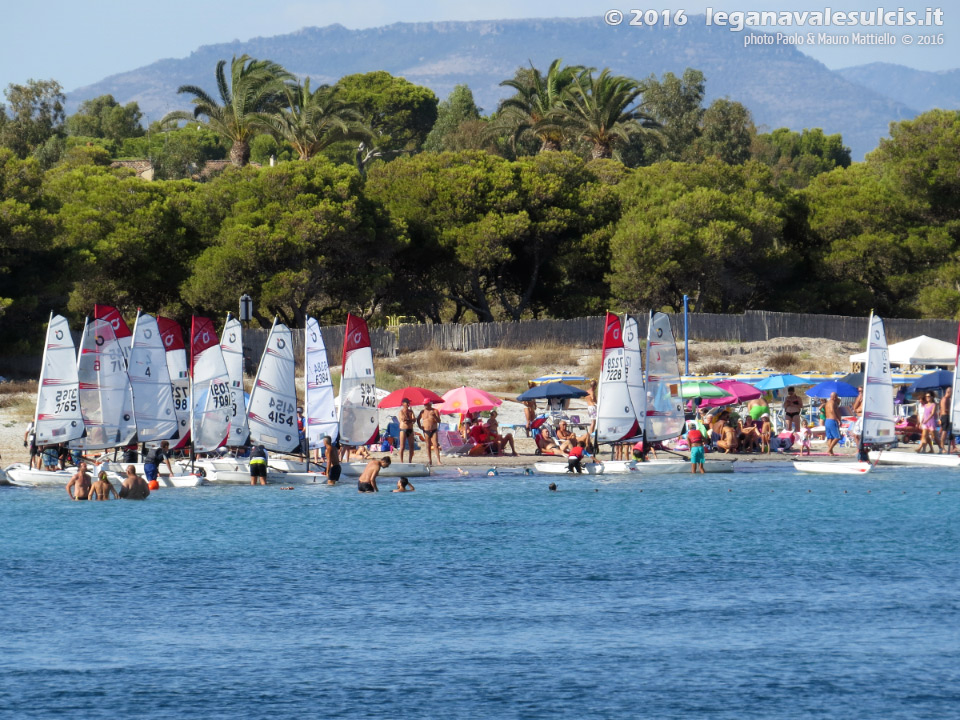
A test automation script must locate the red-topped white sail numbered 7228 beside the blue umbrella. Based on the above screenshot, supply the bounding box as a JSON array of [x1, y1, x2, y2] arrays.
[[596, 313, 640, 443]]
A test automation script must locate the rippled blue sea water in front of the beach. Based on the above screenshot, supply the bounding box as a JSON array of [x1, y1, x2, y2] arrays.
[[0, 466, 960, 719]]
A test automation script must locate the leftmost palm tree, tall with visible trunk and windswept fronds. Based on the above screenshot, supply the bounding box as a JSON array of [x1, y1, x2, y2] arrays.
[[161, 55, 294, 167]]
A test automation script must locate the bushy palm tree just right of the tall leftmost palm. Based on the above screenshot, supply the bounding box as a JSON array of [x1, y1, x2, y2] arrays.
[[270, 78, 373, 160]]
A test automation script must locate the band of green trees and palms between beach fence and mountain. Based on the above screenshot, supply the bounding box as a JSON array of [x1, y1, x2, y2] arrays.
[[0, 56, 960, 352]]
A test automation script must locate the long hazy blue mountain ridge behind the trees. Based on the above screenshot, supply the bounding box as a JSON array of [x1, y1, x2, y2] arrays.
[[68, 15, 936, 158]]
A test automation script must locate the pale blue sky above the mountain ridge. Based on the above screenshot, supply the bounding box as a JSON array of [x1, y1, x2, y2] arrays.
[[0, 0, 960, 91]]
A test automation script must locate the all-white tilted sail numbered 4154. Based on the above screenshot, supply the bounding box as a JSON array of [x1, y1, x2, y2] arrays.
[[247, 319, 300, 452]]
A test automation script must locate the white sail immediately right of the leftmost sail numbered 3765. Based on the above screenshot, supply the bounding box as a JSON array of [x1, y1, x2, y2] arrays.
[[71, 320, 137, 450]]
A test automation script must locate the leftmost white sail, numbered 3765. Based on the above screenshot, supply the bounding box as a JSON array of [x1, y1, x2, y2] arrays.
[[34, 313, 84, 446]]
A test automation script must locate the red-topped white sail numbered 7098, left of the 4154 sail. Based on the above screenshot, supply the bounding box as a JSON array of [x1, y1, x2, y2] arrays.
[[190, 315, 233, 452]]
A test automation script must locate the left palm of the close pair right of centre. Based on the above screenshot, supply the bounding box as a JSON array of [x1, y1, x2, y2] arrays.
[[495, 58, 589, 152]]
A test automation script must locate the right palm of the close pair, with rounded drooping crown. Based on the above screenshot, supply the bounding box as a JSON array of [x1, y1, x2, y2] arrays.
[[553, 68, 657, 159]]
